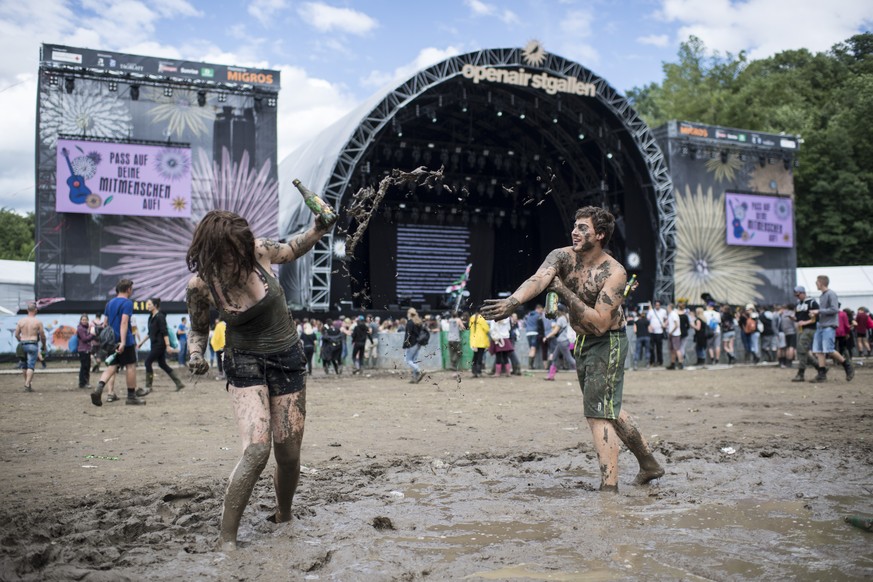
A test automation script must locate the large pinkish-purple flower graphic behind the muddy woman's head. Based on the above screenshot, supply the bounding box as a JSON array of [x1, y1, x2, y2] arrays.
[[102, 148, 279, 301]]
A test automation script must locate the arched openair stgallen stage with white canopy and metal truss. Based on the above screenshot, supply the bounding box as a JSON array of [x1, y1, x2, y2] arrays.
[[279, 43, 676, 311]]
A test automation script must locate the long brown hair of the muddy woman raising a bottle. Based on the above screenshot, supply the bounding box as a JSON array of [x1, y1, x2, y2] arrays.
[[185, 210, 256, 287]]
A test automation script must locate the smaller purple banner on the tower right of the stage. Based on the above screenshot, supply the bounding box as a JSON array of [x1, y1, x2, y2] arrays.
[[724, 192, 794, 248]]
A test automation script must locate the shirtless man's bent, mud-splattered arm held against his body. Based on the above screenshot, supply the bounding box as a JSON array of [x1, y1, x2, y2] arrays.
[[549, 268, 627, 335]]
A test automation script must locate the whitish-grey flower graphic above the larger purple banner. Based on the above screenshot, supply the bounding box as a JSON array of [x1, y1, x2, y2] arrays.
[[39, 81, 132, 147]]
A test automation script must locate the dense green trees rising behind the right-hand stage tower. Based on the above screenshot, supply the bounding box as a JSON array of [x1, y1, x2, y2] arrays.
[[628, 33, 873, 267]]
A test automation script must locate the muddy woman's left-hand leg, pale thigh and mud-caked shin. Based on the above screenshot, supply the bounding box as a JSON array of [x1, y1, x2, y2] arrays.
[[220, 386, 270, 551]]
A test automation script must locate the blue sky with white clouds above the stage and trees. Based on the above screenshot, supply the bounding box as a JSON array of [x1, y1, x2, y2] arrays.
[[0, 0, 873, 212]]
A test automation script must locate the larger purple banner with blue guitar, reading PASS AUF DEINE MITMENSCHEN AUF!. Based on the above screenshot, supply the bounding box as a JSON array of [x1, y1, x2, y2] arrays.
[[55, 139, 191, 218]]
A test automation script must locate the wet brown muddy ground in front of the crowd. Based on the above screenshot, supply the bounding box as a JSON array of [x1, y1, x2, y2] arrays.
[[0, 361, 873, 581]]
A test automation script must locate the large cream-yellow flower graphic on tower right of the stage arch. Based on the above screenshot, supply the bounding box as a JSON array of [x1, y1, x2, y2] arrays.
[[674, 186, 763, 304]]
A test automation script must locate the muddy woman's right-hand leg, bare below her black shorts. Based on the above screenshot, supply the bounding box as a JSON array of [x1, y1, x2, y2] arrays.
[[270, 389, 306, 523]]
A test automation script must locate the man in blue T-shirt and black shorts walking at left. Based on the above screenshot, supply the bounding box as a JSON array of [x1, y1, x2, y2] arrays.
[[91, 279, 146, 406]]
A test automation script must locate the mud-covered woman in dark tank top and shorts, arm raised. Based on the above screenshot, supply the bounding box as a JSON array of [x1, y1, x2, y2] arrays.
[[187, 210, 336, 550]]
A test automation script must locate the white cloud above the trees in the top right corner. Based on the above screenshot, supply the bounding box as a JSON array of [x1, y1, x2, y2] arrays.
[[659, 0, 873, 59]]
